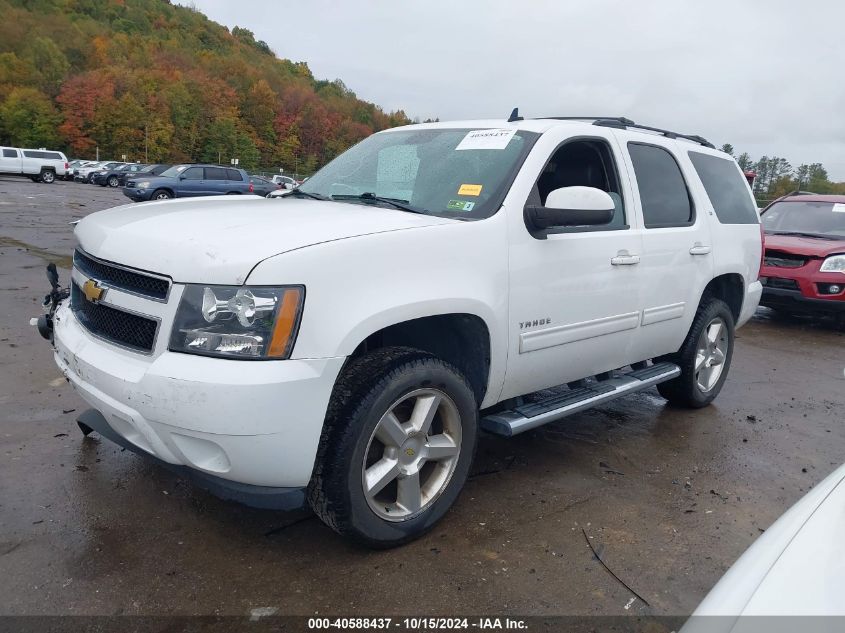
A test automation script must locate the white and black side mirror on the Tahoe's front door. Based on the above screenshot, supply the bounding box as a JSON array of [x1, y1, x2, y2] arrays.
[[525, 187, 616, 233]]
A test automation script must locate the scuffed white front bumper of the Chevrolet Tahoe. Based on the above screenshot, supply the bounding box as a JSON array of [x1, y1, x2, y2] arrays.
[[54, 301, 344, 488]]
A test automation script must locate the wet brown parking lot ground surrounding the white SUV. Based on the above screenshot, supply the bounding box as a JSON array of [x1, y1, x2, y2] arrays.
[[0, 178, 845, 615]]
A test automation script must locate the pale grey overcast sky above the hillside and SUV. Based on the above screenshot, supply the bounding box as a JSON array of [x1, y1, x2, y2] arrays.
[[181, 0, 845, 180]]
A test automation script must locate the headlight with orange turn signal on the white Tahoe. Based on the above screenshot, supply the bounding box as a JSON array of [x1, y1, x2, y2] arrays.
[[170, 284, 305, 359]]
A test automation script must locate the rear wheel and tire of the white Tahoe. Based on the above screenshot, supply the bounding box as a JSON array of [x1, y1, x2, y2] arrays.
[[657, 297, 734, 409]]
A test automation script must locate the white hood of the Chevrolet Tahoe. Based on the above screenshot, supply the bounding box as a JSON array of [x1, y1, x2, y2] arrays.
[[75, 196, 457, 284]]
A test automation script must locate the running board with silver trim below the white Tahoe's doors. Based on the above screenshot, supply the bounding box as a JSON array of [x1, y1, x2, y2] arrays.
[[481, 363, 681, 437]]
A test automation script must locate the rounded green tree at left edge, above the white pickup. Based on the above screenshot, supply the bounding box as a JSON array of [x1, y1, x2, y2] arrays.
[[0, 88, 60, 147]]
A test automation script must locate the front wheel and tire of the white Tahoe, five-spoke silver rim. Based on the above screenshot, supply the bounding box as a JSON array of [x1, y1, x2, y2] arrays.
[[308, 348, 478, 549]]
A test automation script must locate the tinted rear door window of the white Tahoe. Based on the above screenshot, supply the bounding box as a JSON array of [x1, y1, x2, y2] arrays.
[[628, 143, 693, 229]]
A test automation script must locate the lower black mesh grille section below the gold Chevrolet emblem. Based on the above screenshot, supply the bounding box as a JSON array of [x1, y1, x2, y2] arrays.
[[70, 282, 158, 353]]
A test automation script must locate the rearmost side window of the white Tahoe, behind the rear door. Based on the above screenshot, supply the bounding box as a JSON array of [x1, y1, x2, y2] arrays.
[[689, 152, 757, 224]]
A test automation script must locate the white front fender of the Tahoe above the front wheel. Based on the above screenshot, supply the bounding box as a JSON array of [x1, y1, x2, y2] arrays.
[[247, 214, 508, 405]]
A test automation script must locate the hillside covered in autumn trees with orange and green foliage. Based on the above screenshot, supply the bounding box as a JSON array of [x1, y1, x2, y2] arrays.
[[0, 0, 409, 173]]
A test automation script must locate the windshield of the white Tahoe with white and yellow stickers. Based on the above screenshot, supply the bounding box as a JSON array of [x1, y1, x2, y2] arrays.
[[299, 128, 539, 219]]
